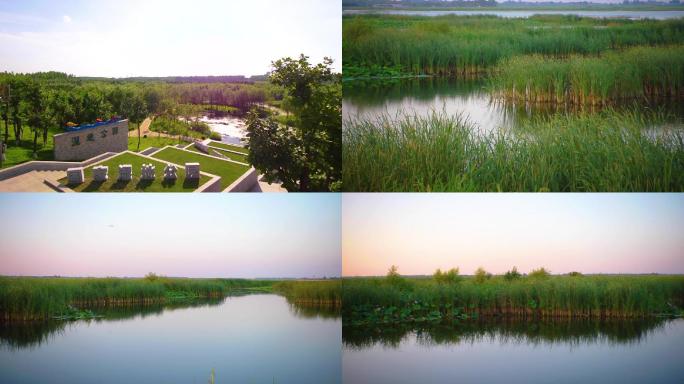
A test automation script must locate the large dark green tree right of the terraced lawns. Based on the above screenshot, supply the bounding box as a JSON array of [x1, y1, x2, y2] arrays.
[[247, 55, 342, 191]]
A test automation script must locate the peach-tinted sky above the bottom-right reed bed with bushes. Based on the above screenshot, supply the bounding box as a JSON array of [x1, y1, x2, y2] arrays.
[[342, 193, 684, 276]]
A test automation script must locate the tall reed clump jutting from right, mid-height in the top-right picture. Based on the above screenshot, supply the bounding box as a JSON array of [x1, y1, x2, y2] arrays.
[[490, 45, 684, 105]]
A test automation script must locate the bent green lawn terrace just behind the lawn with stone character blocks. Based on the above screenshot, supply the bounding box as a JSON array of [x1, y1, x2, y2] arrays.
[[153, 148, 249, 189]]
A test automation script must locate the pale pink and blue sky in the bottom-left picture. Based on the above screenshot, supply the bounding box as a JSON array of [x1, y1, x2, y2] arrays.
[[0, 193, 341, 278]]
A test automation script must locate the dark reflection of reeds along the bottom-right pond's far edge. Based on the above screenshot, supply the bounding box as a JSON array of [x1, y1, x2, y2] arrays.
[[342, 318, 682, 349]]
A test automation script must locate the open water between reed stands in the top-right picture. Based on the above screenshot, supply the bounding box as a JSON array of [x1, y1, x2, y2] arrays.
[[342, 77, 684, 133]]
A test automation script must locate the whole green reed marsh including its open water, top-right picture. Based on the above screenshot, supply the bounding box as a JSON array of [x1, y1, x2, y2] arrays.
[[343, 15, 684, 191]]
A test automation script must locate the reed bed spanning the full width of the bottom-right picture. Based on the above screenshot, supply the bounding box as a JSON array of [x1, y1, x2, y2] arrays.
[[342, 275, 684, 325]]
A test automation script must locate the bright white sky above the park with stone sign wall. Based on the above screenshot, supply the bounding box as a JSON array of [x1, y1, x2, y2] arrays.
[[0, 0, 342, 77]]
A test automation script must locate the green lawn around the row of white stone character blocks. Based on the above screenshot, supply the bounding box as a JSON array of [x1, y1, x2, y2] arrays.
[[60, 153, 210, 192]]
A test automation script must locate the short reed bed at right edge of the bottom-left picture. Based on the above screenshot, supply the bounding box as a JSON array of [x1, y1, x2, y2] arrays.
[[273, 279, 342, 307]]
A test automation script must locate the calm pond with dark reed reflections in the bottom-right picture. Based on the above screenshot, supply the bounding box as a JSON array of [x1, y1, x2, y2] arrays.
[[342, 319, 684, 384]]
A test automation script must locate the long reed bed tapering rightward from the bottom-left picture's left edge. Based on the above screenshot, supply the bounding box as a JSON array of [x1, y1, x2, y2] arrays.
[[0, 275, 272, 321]]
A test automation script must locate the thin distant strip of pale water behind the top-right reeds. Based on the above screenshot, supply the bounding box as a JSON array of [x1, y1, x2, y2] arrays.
[[342, 9, 684, 20]]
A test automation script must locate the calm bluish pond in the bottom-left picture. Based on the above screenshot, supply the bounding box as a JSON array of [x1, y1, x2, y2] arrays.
[[0, 294, 341, 383]]
